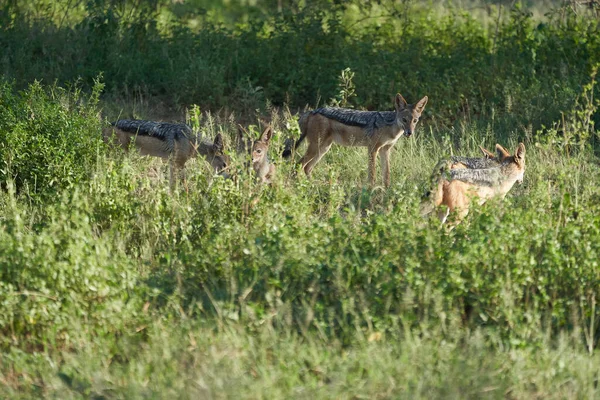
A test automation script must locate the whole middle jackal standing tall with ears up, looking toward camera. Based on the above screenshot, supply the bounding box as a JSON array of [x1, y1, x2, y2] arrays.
[[283, 93, 428, 186]]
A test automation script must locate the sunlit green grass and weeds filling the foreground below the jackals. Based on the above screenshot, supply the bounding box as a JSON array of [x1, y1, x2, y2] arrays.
[[0, 91, 600, 398]]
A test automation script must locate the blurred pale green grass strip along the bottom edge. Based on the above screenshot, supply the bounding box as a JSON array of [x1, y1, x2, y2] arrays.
[[0, 322, 599, 399]]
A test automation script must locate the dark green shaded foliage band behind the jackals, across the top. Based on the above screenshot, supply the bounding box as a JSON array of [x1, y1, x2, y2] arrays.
[[0, 0, 600, 131]]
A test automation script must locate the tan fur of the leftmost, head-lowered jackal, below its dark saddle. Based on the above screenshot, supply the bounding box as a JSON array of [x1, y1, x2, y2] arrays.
[[102, 126, 229, 187]]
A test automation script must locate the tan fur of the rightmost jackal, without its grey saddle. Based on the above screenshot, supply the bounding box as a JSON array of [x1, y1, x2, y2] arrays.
[[421, 143, 525, 223]]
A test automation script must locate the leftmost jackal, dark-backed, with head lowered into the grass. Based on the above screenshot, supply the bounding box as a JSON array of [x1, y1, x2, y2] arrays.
[[102, 119, 229, 185]]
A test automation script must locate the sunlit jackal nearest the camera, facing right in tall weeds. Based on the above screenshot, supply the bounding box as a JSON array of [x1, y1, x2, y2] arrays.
[[421, 143, 525, 223]]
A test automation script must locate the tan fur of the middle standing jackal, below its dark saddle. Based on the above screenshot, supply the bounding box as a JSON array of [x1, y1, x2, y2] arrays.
[[300, 93, 428, 186]]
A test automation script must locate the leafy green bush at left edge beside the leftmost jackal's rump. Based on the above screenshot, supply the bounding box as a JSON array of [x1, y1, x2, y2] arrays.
[[0, 82, 103, 200]]
